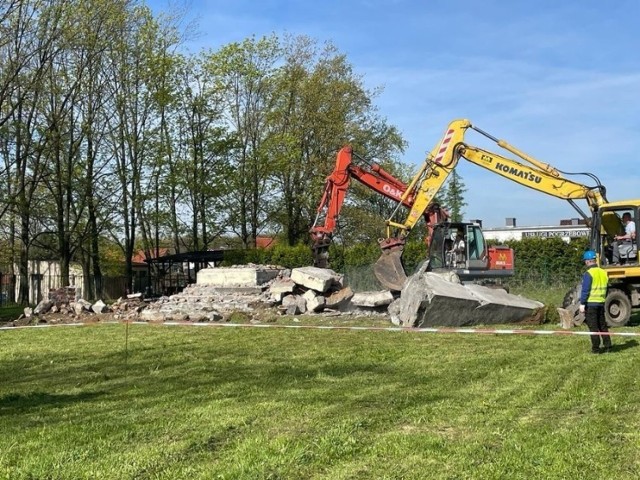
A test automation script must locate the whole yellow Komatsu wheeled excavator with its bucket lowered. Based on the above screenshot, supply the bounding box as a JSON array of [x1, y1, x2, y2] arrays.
[[374, 119, 640, 326]]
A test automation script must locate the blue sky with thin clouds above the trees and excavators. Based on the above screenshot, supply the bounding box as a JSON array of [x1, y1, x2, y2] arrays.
[[147, 0, 640, 227]]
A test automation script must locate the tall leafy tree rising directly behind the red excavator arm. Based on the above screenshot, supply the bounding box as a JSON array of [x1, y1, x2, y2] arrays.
[[269, 36, 403, 245]]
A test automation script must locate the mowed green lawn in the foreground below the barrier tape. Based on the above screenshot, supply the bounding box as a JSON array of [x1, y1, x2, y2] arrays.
[[0, 324, 640, 480]]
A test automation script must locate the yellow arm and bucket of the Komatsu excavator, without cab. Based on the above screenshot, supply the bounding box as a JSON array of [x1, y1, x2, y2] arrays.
[[374, 120, 607, 290]]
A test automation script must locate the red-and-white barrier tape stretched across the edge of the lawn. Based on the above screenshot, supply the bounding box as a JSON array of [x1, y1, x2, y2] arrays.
[[0, 321, 640, 337]]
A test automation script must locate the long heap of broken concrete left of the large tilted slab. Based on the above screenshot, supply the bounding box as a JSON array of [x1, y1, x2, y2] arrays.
[[13, 265, 393, 324]]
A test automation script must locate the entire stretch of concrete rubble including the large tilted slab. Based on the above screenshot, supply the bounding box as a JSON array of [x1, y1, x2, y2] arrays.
[[10, 265, 543, 327]]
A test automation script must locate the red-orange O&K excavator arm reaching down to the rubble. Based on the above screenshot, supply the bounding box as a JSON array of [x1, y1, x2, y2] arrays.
[[311, 145, 449, 268]]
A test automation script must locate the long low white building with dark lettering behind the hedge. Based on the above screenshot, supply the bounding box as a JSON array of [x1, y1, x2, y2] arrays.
[[482, 218, 589, 246]]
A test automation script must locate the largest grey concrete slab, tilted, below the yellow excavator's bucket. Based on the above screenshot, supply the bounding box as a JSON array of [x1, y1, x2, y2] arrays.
[[389, 269, 544, 327]]
